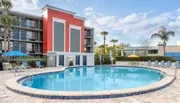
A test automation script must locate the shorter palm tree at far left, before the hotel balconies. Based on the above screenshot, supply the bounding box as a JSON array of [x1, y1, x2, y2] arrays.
[[0, 15, 18, 51]]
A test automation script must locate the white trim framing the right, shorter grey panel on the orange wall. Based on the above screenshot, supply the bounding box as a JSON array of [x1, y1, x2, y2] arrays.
[[69, 25, 81, 52]]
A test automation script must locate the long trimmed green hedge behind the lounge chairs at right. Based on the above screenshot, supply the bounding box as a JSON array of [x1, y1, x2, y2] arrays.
[[116, 56, 175, 62]]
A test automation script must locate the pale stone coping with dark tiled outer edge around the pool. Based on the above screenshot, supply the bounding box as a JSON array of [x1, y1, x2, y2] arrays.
[[6, 65, 175, 99]]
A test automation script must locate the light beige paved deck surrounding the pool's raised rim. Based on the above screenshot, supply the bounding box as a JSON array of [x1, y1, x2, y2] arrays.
[[0, 68, 180, 103]]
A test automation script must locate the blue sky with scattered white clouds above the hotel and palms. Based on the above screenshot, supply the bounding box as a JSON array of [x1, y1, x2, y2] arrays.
[[12, 0, 180, 46]]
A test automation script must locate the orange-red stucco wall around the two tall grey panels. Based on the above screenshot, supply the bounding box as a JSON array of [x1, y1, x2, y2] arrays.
[[43, 9, 84, 54]]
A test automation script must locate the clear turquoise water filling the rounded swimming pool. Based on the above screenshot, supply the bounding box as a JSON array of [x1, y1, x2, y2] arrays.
[[22, 66, 163, 91]]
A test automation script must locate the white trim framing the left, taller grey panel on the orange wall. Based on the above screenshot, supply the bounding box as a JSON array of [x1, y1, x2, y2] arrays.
[[52, 17, 66, 52]]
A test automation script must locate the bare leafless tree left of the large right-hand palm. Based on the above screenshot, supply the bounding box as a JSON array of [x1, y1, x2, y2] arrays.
[[138, 38, 151, 56]]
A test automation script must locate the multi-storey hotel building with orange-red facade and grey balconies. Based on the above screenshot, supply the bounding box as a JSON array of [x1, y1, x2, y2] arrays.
[[0, 5, 94, 66]]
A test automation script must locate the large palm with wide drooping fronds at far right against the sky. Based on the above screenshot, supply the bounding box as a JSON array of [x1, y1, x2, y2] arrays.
[[151, 26, 175, 55]]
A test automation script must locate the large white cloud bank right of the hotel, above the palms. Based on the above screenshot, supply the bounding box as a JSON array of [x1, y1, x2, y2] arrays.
[[84, 7, 180, 45]]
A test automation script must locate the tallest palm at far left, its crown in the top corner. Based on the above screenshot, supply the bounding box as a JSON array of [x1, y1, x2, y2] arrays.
[[0, 0, 12, 52]]
